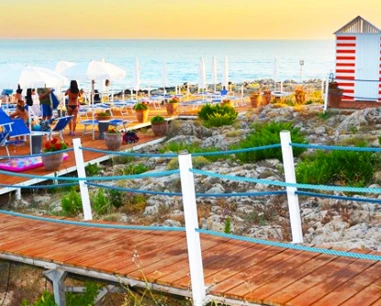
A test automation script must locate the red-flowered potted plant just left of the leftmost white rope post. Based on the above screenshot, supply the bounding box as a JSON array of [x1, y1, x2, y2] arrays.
[[41, 138, 68, 171]]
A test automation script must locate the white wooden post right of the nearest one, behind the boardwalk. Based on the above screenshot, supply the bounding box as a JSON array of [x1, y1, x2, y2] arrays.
[[280, 131, 303, 243]]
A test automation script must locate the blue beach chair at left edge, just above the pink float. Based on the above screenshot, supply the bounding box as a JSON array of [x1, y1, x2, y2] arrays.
[[0, 119, 30, 156]]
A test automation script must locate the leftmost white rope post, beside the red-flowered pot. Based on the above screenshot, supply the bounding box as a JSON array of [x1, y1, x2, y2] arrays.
[[73, 138, 93, 220]]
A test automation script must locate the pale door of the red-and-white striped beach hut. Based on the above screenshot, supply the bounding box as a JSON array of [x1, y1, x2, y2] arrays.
[[355, 34, 380, 101]]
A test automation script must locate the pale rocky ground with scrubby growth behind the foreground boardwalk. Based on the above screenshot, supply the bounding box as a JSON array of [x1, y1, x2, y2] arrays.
[[3, 104, 381, 304]]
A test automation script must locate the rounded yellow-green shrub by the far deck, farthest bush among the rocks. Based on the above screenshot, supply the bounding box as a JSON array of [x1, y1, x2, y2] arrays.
[[198, 104, 238, 127]]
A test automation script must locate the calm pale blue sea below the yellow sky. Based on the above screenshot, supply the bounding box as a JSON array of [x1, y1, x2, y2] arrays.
[[0, 40, 335, 88]]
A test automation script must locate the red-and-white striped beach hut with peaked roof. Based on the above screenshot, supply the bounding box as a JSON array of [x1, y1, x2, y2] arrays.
[[334, 16, 381, 102]]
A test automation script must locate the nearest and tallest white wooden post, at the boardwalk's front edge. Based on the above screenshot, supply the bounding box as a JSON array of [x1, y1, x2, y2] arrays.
[[179, 153, 206, 306]]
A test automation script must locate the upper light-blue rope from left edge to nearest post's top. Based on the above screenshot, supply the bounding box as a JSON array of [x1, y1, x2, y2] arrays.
[[0, 170, 179, 181]]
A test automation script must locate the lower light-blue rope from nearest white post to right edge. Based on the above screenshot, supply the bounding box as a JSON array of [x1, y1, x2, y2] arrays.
[[195, 228, 381, 261]]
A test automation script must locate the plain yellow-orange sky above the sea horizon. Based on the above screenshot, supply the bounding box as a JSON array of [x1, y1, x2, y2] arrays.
[[0, 0, 381, 39]]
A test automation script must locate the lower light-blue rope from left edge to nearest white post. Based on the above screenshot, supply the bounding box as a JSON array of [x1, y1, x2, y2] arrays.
[[0, 210, 185, 232]]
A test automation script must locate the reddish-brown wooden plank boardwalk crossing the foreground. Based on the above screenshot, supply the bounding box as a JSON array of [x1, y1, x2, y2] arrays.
[[0, 213, 381, 306]]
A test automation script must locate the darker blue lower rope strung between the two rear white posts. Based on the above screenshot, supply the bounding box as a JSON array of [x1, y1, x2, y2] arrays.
[[85, 183, 287, 198]]
